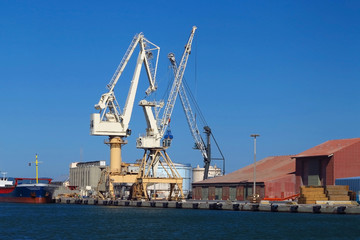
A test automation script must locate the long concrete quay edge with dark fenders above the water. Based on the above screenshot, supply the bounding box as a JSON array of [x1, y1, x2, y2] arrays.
[[55, 198, 360, 214]]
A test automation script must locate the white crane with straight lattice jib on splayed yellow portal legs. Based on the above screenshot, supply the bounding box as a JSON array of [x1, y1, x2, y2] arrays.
[[132, 26, 196, 199]]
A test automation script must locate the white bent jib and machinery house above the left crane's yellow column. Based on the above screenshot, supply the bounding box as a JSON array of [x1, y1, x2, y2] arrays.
[[90, 33, 160, 137]]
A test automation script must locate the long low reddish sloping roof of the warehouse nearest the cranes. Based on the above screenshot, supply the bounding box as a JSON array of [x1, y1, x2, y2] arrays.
[[194, 155, 295, 185]]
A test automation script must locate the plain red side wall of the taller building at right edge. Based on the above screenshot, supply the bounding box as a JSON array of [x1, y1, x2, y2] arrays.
[[331, 143, 360, 181]]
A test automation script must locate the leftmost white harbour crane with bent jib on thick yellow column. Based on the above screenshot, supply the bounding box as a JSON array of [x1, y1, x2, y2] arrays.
[[90, 33, 160, 197]]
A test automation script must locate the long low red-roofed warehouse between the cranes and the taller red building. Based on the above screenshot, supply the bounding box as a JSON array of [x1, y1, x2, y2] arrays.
[[193, 156, 295, 201]]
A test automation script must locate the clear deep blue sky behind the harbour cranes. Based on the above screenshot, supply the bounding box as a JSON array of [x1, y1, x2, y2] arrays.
[[0, 1, 360, 177]]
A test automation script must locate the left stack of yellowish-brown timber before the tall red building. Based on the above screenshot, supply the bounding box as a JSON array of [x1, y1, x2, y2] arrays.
[[298, 186, 329, 204]]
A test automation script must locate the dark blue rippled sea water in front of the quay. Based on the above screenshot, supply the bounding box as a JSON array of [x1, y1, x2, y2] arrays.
[[0, 203, 360, 240]]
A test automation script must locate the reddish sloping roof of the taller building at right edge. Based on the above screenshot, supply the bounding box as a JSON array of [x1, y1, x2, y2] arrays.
[[294, 138, 360, 158]]
